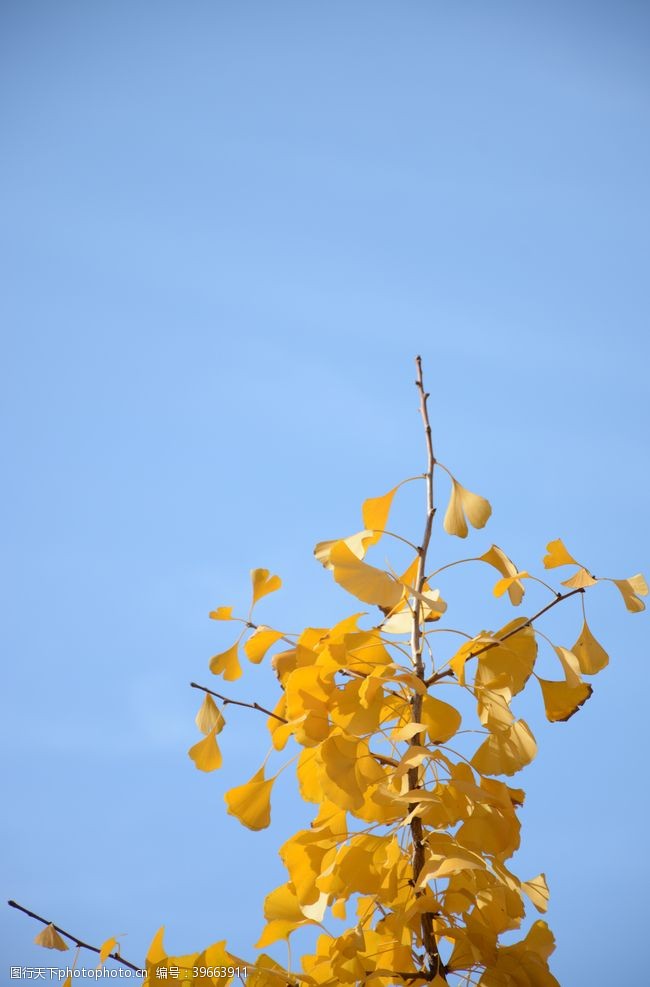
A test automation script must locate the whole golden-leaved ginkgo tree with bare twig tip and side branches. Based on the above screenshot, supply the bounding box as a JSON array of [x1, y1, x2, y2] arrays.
[[21, 357, 648, 987]]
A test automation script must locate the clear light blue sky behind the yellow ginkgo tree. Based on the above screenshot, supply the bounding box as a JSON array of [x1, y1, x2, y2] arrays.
[[0, 0, 650, 987]]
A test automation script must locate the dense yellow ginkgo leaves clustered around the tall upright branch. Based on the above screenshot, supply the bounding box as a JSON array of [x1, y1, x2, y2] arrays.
[[181, 478, 645, 987]]
